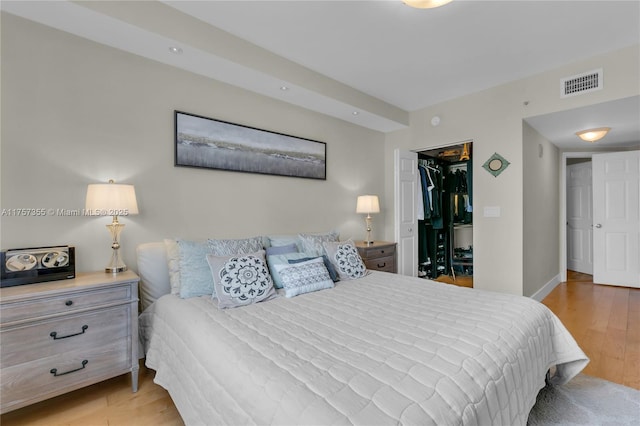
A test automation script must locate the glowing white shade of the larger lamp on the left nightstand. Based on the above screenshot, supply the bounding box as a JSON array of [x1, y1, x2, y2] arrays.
[[85, 183, 138, 216]]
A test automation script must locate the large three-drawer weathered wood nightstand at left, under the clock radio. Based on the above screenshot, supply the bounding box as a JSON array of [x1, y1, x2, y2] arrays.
[[0, 271, 139, 413]]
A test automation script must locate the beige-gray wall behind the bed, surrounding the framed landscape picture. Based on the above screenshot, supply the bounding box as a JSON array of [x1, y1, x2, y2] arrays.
[[0, 13, 386, 271]]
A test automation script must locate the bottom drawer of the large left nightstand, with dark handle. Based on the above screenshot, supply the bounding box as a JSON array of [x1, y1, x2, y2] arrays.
[[0, 338, 132, 412]]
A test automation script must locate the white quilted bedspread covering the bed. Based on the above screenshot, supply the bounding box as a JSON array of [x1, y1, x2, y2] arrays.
[[141, 272, 588, 425]]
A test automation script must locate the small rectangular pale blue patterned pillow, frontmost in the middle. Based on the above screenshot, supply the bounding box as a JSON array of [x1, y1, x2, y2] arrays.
[[274, 257, 334, 297]]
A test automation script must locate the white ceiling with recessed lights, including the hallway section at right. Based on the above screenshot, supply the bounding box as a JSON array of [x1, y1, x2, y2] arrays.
[[0, 0, 640, 149]]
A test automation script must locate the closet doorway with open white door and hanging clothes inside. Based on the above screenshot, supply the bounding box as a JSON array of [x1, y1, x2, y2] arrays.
[[395, 141, 473, 287]]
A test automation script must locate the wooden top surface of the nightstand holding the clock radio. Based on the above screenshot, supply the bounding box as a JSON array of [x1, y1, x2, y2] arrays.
[[0, 271, 140, 302]]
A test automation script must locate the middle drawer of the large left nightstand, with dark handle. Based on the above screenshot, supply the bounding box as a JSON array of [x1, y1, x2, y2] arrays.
[[0, 305, 131, 369]]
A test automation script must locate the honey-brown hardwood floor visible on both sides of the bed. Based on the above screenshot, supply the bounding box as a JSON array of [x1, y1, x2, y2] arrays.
[[0, 271, 640, 426]]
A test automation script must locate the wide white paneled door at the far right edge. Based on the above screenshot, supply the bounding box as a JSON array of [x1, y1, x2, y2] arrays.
[[592, 151, 640, 287]]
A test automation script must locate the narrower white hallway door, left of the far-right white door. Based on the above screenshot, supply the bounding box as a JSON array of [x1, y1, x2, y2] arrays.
[[567, 161, 593, 275]]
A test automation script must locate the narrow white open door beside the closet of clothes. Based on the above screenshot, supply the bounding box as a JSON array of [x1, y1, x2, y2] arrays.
[[394, 149, 418, 277]]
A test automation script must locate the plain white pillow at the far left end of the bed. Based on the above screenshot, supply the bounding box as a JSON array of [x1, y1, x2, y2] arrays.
[[136, 242, 171, 310]]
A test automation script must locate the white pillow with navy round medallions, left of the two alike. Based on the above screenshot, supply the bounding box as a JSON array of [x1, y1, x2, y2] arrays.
[[207, 250, 277, 309]]
